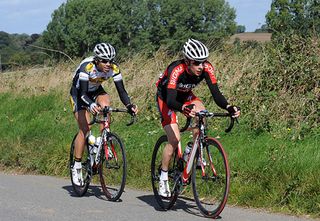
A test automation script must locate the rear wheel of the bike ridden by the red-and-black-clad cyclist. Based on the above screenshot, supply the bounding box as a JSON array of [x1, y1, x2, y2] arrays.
[[151, 135, 178, 210]]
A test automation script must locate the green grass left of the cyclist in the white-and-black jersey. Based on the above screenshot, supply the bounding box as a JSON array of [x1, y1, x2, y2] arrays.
[[0, 93, 76, 175]]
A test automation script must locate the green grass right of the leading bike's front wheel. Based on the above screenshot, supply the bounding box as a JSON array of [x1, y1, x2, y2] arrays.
[[223, 134, 320, 216]]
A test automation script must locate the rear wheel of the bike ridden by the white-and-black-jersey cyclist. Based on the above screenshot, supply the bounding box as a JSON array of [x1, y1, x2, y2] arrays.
[[69, 134, 91, 197]]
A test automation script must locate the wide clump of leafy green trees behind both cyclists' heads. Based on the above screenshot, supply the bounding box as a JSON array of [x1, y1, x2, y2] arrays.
[[42, 0, 236, 56]]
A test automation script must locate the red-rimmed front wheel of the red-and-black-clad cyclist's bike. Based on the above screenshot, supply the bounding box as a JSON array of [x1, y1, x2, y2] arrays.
[[192, 138, 230, 218]]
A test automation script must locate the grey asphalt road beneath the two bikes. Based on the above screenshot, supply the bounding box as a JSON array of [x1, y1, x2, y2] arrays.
[[0, 172, 311, 221]]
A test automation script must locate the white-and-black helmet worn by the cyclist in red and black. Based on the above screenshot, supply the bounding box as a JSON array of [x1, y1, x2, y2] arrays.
[[183, 38, 209, 62]]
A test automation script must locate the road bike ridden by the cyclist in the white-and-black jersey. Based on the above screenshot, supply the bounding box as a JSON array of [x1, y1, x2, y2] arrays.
[[69, 107, 135, 201]]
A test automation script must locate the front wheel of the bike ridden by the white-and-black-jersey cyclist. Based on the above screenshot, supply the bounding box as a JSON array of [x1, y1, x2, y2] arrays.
[[99, 133, 127, 201]]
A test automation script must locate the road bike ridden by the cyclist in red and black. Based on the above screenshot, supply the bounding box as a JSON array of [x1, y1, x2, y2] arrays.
[[151, 110, 235, 218]]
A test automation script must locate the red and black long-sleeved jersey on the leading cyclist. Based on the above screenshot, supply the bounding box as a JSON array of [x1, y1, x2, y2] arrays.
[[156, 59, 228, 111]]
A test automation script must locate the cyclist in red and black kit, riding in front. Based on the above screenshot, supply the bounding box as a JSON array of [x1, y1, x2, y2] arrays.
[[156, 39, 240, 197]]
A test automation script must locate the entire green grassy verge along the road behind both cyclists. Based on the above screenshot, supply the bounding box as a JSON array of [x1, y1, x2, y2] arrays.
[[0, 91, 320, 217]]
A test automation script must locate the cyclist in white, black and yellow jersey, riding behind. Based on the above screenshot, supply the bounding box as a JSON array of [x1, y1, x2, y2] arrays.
[[70, 43, 138, 186]]
